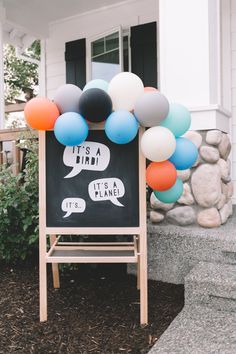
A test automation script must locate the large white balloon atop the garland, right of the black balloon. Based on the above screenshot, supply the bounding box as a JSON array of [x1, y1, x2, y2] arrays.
[[108, 72, 144, 111]]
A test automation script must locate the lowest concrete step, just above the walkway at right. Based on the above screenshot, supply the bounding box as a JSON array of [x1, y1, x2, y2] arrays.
[[185, 262, 236, 312]]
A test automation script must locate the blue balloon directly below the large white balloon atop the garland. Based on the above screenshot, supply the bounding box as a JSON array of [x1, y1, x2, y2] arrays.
[[105, 110, 139, 144]]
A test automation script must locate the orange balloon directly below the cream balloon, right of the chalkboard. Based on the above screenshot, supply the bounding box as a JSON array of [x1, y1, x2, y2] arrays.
[[146, 161, 177, 191]]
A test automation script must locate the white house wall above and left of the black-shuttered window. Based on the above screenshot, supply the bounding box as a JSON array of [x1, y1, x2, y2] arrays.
[[46, 0, 158, 98]]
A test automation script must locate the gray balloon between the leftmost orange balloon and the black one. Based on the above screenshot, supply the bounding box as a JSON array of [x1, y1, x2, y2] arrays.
[[54, 84, 82, 113]]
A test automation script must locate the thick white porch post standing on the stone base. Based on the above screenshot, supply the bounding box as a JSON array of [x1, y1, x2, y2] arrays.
[[159, 0, 230, 132]]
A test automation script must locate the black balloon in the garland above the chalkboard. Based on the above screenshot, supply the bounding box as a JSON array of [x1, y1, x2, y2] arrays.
[[79, 88, 112, 123]]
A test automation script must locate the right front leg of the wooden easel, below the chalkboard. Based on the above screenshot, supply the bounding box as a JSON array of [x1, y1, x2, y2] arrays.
[[139, 235, 148, 325]]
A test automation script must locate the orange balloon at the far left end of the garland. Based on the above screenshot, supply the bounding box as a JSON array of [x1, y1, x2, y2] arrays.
[[24, 97, 60, 130]]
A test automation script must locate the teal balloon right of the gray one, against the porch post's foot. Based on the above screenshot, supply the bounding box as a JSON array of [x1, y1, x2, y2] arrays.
[[160, 103, 191, 138]]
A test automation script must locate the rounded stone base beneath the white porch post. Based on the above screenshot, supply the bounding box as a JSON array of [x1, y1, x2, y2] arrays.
[[150, 130, 233, 227]]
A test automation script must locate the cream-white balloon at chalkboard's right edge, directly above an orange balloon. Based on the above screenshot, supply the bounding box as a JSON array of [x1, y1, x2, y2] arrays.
[[141, 127, 176, 162]]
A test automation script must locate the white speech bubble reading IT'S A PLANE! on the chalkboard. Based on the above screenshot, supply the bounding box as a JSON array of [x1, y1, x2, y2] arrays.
[[88, 178, 125, 207]]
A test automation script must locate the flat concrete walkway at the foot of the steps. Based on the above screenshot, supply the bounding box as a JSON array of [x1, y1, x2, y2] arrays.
[[148, 306, 236, 354]]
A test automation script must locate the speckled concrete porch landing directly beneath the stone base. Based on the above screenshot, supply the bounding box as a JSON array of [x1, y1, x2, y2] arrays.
[[133, 206, 236, 284]]
